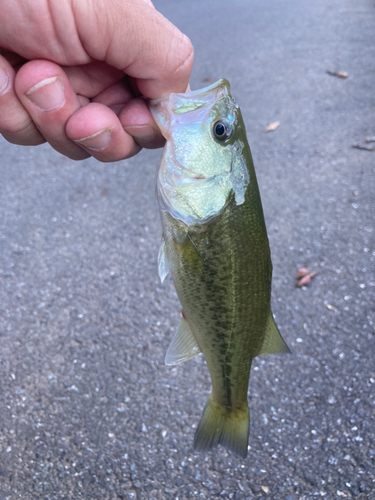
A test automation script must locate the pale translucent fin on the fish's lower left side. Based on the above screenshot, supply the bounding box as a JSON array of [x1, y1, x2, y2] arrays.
[[165, 318, 201, 365]]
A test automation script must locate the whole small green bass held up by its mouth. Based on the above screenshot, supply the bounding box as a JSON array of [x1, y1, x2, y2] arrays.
[[149, 79, 290, 458]]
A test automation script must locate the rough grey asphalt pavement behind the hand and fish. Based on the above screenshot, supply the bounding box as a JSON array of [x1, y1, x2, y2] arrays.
[[0, 0, 375, 500]]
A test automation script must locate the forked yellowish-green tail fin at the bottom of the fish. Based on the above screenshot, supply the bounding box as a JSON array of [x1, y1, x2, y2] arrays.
[[194, 394, 250, 458]]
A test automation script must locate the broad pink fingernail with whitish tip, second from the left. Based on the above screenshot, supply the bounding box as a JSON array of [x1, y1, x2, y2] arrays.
[[26, 76, 65, 111]]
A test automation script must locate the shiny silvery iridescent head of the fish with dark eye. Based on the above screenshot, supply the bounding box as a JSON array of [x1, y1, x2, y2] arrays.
[[149, 79, 249, 225]]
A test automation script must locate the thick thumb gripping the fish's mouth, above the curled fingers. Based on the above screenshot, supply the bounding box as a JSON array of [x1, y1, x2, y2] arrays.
[[72, 0, 194, 99]]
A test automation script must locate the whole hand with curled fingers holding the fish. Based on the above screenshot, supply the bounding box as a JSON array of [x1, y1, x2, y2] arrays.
[[0, 0, 193, 161]]
